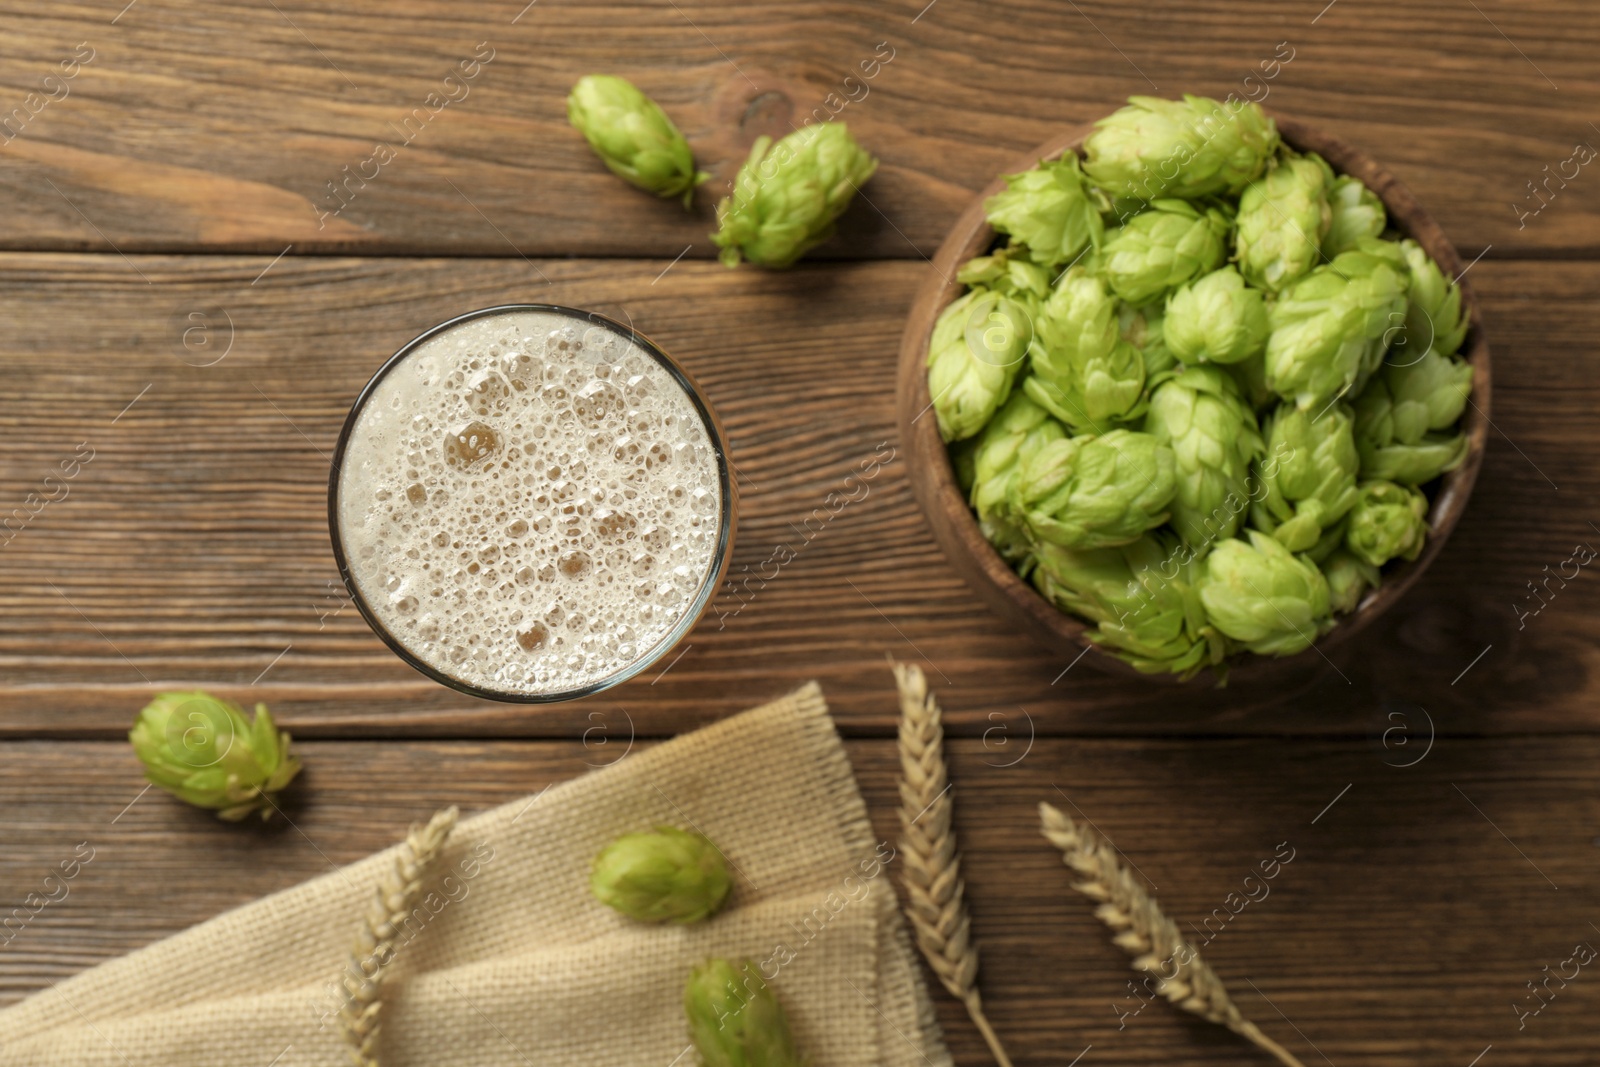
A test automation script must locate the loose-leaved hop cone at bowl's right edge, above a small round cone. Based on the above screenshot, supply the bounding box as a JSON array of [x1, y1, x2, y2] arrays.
[[1355, 349, 1472, 485]]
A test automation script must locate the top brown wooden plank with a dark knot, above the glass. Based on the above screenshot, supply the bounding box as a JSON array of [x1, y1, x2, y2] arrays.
[[0, 0, 1600, 259]]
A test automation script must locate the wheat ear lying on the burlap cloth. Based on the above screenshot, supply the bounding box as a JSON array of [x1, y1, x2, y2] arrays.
[[339, 808, 456, 1067]]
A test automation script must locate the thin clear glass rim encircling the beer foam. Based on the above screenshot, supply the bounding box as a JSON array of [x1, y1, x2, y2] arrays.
[[328, 304, 738, 704]]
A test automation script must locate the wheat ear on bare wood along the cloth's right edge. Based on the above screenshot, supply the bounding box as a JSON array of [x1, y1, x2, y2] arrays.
[[894, 664, 1011, 1067]]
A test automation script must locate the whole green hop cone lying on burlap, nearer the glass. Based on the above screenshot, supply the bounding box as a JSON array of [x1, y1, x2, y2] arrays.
[[589, 825, 733, 923]]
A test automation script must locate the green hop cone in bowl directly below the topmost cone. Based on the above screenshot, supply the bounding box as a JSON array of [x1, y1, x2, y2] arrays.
[[1098, 200, 1230, 304]]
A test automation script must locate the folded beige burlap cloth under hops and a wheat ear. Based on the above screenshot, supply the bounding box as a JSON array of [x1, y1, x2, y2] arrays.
[[0, 685, 950, 1067]]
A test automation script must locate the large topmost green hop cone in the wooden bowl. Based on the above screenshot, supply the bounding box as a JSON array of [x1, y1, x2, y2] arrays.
[[1083, 96, 1278, 200]]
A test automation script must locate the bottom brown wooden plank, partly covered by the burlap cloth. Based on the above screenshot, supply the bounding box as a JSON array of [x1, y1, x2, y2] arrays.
[[0, 737, 1600, 1067]]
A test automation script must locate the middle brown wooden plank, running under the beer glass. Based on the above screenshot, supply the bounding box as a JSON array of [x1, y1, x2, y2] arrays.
[[0, 254, 1600, 737]]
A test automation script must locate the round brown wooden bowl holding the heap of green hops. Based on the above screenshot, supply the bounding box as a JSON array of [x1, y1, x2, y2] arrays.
[[898, 115, 1490, 685]]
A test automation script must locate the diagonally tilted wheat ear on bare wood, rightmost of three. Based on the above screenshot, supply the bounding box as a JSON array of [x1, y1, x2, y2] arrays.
[[1038, 805, 1304, 1067]]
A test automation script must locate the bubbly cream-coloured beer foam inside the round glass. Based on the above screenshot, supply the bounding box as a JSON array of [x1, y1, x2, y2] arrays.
[[338, 310, 723, 694]]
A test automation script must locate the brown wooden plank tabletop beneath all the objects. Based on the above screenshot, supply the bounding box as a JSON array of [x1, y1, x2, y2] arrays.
[[0, 0, 1600, 1067]]
